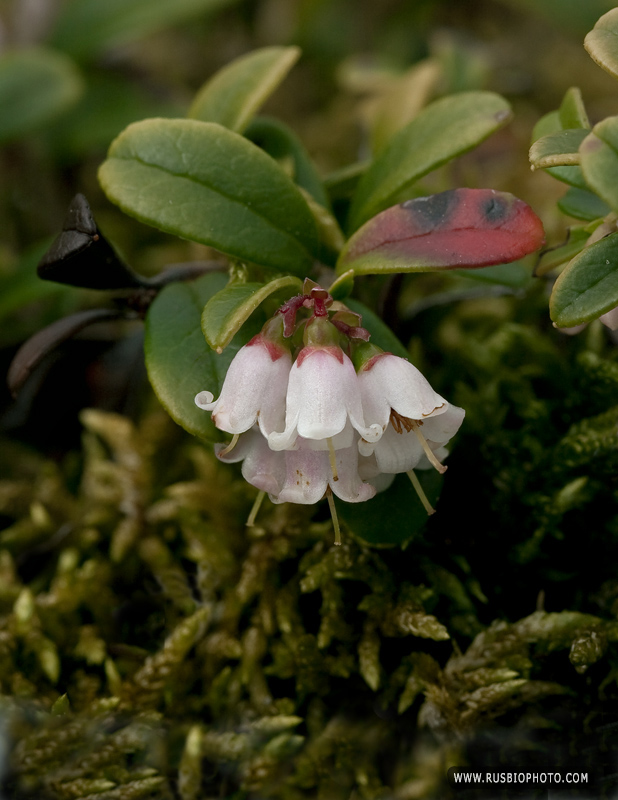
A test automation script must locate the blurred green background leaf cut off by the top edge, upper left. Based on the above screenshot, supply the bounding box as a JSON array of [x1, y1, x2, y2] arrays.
[[51, 0, 236, 60]]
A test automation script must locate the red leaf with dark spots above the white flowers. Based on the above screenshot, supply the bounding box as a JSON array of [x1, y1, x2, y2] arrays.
[[337, 189, 545, 274]]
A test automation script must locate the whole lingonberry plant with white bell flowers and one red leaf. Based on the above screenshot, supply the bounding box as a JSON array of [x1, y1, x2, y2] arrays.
[[14, 47, 544, 543]]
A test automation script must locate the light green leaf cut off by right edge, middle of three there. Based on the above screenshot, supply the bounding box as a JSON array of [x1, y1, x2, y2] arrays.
[[580, 117, 618, 211]]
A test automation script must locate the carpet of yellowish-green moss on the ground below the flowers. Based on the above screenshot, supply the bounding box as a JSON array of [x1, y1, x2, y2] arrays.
[[0, 317, 618, 800]]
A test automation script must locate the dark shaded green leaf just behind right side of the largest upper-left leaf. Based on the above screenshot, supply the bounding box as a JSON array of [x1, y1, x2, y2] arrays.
[[245, 117, 330, 208]]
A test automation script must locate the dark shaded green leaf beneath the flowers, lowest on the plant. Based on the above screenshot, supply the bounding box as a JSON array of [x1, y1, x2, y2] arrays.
[[337, 469, 442, 546]]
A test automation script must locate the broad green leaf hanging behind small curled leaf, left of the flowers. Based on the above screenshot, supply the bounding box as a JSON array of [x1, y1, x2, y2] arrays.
[[145, 273, 254, 441]]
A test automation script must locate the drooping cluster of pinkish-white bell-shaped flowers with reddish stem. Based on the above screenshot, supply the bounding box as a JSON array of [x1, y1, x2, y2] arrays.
[[195, 281, 464, 536]]
